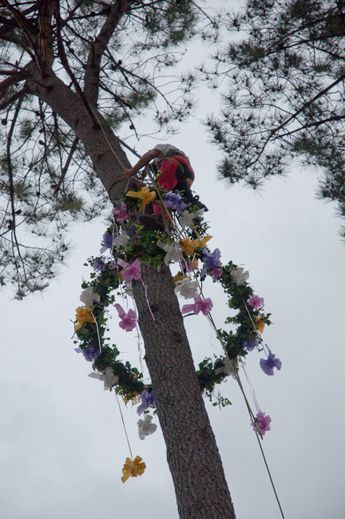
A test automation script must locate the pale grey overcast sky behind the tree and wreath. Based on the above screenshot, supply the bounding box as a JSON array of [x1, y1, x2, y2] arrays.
[[0, 2, 345, 519]]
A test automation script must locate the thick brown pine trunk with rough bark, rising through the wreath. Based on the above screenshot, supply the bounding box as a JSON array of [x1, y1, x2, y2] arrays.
[[32, 70, 235, 519]]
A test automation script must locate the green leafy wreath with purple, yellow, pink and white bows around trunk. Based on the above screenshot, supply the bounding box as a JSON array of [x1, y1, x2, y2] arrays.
[[74, 184, 281, 481]]
